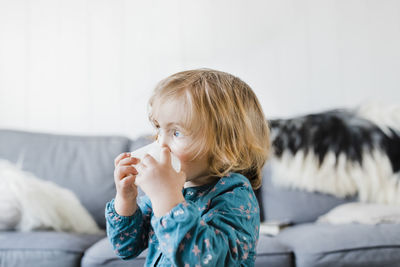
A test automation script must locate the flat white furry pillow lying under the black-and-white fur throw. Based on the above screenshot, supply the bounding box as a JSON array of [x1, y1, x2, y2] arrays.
[[317, 202, 400, 224]]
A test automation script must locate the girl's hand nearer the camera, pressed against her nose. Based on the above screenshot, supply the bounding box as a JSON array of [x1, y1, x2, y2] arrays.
[[135, 148, 186, 216]]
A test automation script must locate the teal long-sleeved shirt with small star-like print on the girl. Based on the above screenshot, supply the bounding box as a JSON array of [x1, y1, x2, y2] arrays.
[[105, 173, 260, 267]]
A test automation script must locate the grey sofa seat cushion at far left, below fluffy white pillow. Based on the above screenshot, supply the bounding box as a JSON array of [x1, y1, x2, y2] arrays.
[[0, 232, 104, 267]]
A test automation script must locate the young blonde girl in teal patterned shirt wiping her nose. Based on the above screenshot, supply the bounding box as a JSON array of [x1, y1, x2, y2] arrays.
[[106, 69, 269, 266]]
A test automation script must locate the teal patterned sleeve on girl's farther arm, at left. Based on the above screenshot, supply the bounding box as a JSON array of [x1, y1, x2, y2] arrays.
[[105, 197, 152, 259]]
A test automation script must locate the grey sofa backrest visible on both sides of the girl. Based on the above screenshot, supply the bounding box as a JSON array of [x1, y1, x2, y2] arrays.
[[0, 130, 354, 228]]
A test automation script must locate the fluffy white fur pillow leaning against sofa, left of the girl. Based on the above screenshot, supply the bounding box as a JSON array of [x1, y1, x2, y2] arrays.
[[0, 160, 101, 234]]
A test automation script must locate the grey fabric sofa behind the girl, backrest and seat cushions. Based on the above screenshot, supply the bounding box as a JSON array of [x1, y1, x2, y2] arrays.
[[0, 129, 400, 267]]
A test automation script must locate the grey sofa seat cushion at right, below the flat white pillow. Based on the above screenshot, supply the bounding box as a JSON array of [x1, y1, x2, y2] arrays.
[[277, 223, 400, 267]]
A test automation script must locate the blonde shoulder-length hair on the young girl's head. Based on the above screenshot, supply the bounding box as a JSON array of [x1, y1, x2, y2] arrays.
[[149, 69, 270, 189]]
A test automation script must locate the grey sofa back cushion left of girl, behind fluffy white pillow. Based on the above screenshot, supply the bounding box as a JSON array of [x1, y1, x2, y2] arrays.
[[0, 130, 130, 228]]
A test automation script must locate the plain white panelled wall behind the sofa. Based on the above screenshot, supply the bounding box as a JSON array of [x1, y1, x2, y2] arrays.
[[0, 0, 400, 137]]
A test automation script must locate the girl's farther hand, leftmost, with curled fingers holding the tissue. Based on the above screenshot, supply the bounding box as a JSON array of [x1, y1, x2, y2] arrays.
[[114, 153, 140, 216]]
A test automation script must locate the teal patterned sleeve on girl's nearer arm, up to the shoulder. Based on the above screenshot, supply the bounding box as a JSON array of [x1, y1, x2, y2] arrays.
[[151, 187, 260, 266]]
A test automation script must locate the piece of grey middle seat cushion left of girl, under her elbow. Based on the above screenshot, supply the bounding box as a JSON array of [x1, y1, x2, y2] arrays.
[[81, 238, 147, 267]]
